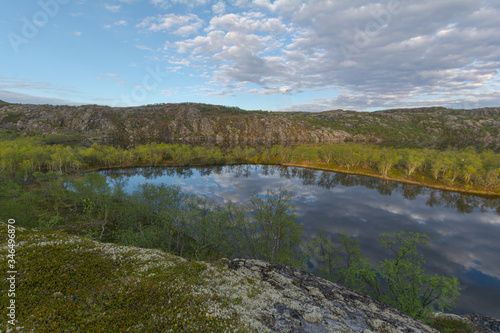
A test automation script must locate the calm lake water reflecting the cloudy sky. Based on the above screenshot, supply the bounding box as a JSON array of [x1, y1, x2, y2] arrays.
[[103, 165, 500, 318]]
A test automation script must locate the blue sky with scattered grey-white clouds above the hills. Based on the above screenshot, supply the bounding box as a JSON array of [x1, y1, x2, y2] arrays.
[[0, 0, 500, 112]]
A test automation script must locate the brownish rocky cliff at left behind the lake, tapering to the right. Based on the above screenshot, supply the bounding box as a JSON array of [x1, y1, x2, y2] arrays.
[[0, 104, 365, 145]]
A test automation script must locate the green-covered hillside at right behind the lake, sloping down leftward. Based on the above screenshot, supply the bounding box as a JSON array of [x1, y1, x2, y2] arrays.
[[293, 107, 500, 150]]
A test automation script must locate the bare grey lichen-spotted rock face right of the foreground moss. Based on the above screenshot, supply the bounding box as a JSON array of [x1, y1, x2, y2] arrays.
[[228, 259, 437, 333]]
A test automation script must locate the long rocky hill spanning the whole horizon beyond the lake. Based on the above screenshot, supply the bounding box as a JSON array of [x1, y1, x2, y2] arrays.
[[0, 103, 500, 150]]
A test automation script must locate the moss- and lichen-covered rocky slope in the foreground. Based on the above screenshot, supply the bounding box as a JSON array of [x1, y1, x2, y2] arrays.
[[0, 223, 498, 333]]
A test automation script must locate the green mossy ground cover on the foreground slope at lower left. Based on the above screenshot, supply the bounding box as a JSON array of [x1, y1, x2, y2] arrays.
[[0, 223, 262, 332]]
